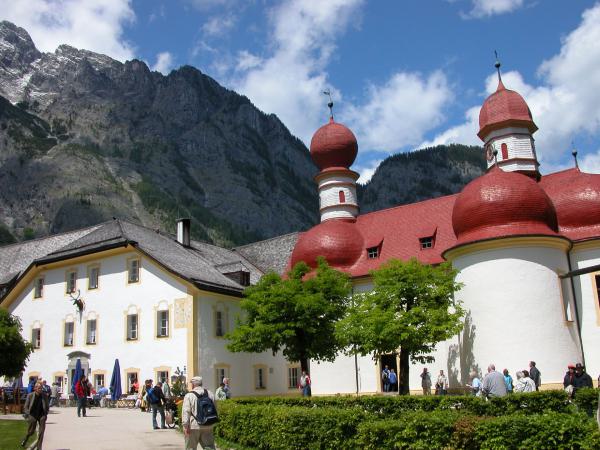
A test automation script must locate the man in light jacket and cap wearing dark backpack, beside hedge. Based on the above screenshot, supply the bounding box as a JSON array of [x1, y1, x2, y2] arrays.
[[181, 377, 219, 450]]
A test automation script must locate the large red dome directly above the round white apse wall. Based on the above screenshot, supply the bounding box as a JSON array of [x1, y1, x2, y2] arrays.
[[452, 167, 557, 244]]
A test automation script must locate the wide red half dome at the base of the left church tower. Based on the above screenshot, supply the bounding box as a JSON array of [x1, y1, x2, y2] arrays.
[[291, 219, 364, 268]]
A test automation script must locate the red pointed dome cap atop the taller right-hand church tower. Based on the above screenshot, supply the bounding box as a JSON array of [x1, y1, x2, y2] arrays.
[[477, 80, 537, 140]]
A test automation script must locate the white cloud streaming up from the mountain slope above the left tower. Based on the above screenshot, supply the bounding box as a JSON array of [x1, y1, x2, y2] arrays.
[[229, 0, 362, 143]]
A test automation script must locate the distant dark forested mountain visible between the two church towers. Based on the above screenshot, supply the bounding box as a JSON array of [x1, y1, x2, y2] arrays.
[[358, 144, 486, 213]]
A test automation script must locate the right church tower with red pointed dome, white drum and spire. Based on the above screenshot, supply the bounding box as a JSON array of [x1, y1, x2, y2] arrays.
[[477, 60, 540, 179]]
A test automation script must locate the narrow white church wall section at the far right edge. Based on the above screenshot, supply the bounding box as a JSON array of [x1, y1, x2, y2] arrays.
[[571, 242, 600, 380]]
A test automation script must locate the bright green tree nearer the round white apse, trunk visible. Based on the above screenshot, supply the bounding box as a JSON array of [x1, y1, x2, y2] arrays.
[[336, 258, 464, 394]]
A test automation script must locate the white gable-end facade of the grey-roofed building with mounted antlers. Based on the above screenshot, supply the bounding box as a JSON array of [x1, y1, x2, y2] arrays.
[[9, 252, 187, 389]]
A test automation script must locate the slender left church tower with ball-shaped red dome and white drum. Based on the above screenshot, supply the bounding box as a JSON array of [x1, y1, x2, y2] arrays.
[[310, 92, 359, 222]]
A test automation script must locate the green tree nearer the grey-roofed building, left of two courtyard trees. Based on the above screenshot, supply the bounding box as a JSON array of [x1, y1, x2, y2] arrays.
[[226, 258, 351, 370]]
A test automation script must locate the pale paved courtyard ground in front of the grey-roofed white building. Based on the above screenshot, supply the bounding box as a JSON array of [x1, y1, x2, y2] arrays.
[[7, 408, 184, 450]]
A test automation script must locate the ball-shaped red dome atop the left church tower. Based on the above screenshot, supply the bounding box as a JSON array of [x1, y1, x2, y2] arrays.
[[310, 118, 358, 170]]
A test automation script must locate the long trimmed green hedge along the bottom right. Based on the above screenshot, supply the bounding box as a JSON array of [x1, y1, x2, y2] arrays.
[[215, 389, 600, 450]]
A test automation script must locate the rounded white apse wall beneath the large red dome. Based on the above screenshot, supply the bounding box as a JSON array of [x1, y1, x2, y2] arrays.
[[440, 246, 580, 389]]
